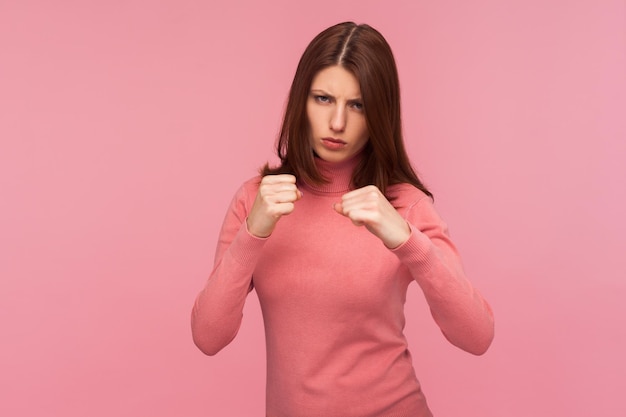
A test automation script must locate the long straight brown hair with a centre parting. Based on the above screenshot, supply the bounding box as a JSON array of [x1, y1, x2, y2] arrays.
[[261, 22, 432, 197]]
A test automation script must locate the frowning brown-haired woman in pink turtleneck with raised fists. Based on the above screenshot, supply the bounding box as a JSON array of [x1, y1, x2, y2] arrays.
[[192, 22, 493, 417]]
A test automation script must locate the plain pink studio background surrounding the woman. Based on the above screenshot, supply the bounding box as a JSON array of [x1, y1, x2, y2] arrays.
[[0, 0, 626, 417]]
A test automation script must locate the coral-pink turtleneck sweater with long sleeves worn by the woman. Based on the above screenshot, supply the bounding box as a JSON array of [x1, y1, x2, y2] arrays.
[[192, 158, 493, 417]]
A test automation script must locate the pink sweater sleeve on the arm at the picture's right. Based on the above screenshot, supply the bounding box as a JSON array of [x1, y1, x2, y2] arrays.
[[393, 197, 494, 355]]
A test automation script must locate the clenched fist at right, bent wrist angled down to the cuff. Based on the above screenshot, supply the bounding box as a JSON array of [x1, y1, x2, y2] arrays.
[[333, 185, 411, 249]]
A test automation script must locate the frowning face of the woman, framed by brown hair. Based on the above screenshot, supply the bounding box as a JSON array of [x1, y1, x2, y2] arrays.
[[306, 65, 368, 162]]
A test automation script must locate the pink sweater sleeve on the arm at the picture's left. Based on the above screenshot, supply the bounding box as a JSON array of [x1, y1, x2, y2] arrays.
[[191, 180, 266, 355]]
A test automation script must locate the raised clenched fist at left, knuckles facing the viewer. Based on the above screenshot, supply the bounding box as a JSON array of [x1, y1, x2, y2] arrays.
[[246, 174, 302, 237]]
